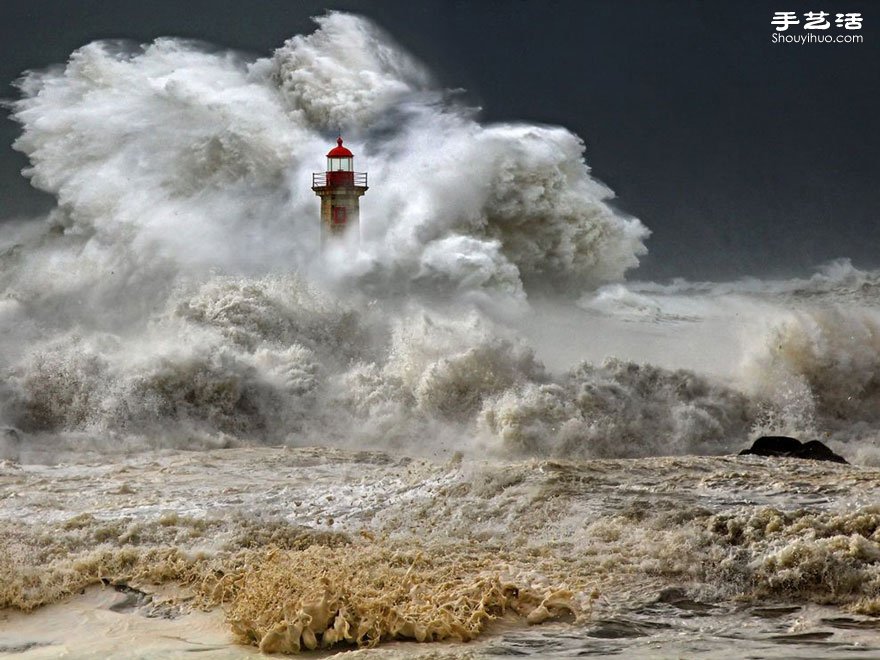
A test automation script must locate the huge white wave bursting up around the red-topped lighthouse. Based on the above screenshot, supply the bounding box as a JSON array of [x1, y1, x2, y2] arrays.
[[13, 13, 647, 295]]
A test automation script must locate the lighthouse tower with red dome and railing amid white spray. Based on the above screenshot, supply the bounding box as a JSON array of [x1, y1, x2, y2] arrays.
[[312, 136, 367, 246]]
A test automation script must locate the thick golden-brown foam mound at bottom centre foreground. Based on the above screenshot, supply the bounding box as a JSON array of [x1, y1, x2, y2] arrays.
[[214, 544, 577, 653]]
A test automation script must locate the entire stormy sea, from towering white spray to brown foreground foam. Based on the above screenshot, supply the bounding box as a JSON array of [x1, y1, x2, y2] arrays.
[[0, 13, 880, 658]]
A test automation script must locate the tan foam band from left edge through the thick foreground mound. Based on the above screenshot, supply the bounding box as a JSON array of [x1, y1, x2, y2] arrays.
[[0, 515, 581, 653]]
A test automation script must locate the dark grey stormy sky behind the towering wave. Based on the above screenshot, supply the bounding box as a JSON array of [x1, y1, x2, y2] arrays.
[[0, 0, 880, 279]]
